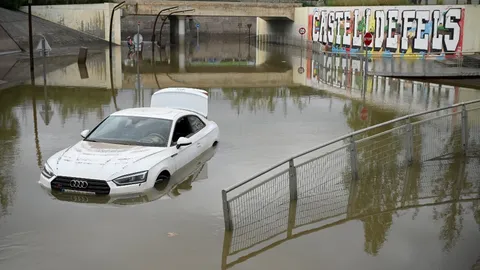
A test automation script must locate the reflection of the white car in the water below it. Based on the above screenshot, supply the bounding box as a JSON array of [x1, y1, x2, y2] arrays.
[[45, 146, 217, 205]]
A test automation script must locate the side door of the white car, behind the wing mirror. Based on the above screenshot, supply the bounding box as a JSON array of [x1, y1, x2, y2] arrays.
[[170, 116, 196, 170]]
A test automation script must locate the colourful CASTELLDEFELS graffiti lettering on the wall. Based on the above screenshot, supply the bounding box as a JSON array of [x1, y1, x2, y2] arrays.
[[307, 6, 465, 56]]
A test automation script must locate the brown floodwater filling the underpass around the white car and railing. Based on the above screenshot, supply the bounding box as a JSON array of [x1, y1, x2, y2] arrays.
[[0, 40, 480, 269]]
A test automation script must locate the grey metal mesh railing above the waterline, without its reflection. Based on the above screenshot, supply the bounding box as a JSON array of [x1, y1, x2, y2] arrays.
[[222, 100, 480, 231]]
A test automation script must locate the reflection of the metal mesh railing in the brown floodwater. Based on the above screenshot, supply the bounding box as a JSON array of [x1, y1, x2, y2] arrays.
[[222, 154, 480, 270]]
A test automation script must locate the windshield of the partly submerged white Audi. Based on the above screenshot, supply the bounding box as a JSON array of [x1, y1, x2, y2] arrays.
[[85, 115, 172, 147]]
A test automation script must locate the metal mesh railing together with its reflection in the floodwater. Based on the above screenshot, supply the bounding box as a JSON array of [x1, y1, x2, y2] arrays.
[[222, 100, 480, 269]]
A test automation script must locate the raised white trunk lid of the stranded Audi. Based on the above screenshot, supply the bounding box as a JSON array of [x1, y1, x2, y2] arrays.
[[150, 87, 208, 117]]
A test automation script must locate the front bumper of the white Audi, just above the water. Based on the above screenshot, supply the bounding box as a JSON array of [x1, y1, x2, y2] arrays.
[[38, 174, 151, 195]]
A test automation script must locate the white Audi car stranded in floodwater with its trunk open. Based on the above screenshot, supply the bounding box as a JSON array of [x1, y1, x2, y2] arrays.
[[39, 88, 219, 195]]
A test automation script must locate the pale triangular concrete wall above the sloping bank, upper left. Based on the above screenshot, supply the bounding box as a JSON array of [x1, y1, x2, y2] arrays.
[[20, 3, 122, 44]]
